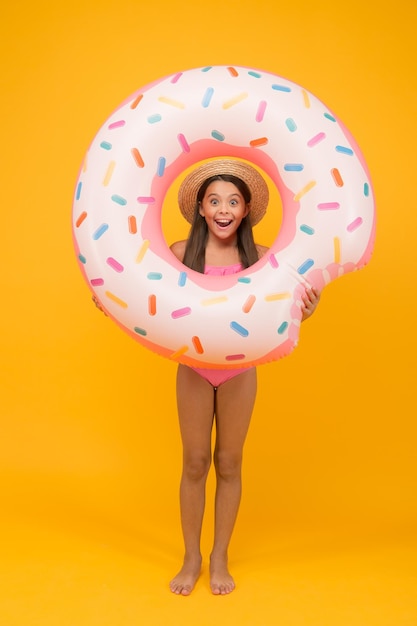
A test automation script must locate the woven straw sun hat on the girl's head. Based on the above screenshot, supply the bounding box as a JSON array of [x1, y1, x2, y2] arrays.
[[178, 159, 269, 226]]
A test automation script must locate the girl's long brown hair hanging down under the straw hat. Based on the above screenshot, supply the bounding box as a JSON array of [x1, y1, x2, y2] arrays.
[[183, 174, 259, 274]]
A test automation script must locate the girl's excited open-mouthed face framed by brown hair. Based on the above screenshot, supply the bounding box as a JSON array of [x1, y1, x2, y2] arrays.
[[199, 180, 249, 241]]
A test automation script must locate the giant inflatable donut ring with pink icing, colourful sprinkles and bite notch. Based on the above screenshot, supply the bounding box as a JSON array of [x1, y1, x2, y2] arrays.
[[73, 66, 375, 369]]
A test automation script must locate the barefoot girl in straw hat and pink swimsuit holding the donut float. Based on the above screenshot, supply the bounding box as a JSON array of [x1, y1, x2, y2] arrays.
[[170, 160, 320, 596]]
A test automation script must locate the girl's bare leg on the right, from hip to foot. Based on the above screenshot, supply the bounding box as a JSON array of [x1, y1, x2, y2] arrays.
[[210, 368, 257, 595]]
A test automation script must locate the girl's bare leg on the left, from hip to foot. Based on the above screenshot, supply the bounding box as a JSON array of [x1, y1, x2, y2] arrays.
[[170, 365, 215, 595]]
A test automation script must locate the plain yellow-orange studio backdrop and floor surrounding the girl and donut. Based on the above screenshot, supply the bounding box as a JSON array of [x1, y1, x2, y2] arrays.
[[0, 0, 417, 626]]
